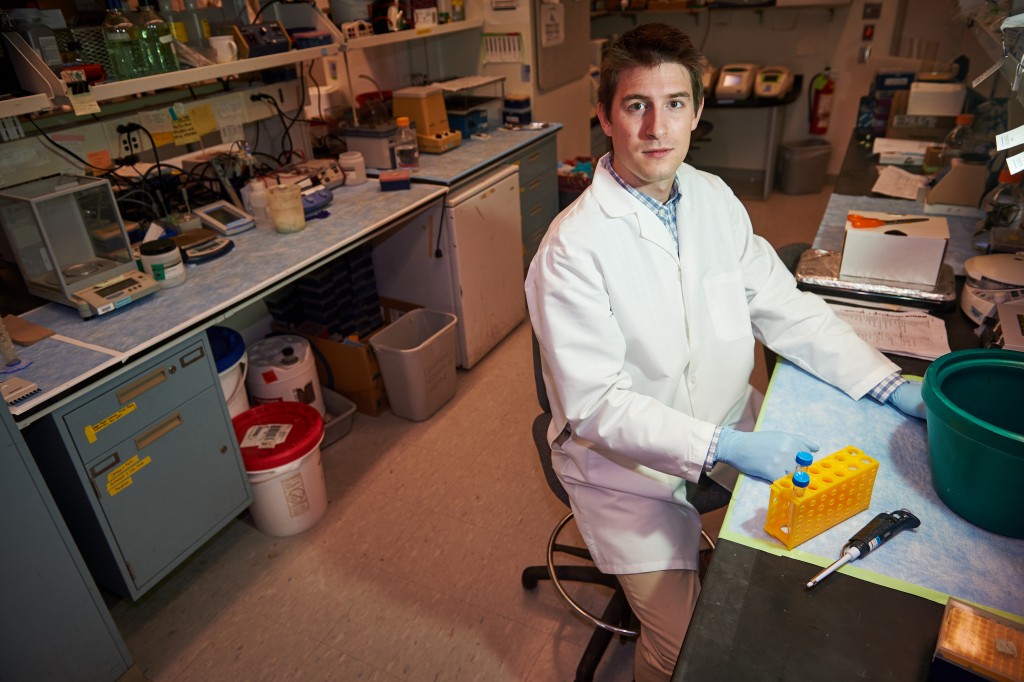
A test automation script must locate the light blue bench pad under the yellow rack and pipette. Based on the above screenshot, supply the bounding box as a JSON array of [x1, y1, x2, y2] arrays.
[[721, 361, 1024, 616]]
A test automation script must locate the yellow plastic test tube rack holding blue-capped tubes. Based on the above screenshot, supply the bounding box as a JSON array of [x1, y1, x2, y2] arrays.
[[765, 445, 879, 549]]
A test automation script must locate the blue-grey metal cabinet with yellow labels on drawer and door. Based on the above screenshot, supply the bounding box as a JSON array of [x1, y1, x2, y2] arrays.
[[25, 334, 252, 599]]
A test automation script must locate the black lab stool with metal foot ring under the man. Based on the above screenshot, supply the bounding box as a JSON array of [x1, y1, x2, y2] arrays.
[[521, 338, 732, 682]]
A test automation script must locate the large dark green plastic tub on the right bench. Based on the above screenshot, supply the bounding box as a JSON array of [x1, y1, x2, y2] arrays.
[[922, 349, 1024, 538]]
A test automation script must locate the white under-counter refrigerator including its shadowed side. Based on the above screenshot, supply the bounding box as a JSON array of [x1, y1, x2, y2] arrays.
[[374, 166, 526, 370]]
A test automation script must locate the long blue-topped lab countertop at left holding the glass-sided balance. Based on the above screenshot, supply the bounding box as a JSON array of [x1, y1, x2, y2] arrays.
[[11, 180, 446, 423]]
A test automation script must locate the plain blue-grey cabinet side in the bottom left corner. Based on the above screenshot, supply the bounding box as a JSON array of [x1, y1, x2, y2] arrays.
[[0, 404, 131, 681]]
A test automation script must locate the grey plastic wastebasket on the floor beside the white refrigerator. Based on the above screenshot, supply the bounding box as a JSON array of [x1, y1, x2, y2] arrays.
[[370, 308, 457, 422]]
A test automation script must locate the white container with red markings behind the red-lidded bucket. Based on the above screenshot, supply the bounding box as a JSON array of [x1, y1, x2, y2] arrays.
[[246, 335, 324, 417]]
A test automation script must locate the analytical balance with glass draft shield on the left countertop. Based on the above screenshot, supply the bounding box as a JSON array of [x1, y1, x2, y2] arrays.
[[0, 175, 160, 318]]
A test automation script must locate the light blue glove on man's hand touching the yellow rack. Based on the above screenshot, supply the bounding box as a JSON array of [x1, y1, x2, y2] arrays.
[[714, 427, 818, 480]]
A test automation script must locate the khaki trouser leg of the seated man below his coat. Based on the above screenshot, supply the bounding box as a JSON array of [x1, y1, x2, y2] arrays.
[[615, 570, 700, 682]]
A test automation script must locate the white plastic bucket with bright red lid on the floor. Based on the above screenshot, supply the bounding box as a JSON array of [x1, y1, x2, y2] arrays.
[[231, 402, 327, 538]]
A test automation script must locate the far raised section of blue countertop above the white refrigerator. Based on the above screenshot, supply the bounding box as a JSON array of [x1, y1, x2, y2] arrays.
[[367, 123, 562, 186]]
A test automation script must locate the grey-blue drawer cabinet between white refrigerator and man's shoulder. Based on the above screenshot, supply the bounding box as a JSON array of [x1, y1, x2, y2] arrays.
[[503, 135, 558, 267]]
